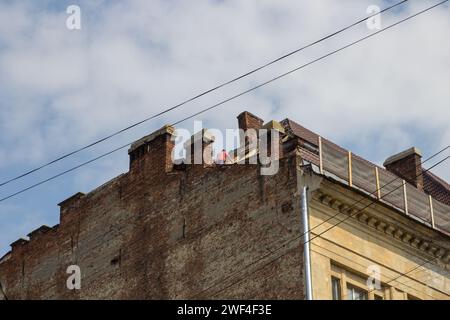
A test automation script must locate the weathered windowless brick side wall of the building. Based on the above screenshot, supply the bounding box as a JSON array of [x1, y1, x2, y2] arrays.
[[0, 136, 303, 299]]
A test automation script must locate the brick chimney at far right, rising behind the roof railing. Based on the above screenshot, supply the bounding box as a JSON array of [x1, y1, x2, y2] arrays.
[[383, 147, 423, 190]]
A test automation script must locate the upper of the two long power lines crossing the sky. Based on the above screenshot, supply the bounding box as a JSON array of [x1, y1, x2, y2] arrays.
[[0, 0, 408, 187]]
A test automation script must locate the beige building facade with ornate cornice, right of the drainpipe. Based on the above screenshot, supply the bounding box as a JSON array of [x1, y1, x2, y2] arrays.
[[310, 176, 450, 300]]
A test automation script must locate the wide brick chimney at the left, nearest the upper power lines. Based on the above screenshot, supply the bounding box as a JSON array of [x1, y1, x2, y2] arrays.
[[128, 125, 175, 175]]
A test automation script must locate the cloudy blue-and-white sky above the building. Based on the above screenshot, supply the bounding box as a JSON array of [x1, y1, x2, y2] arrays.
[[0, 0, 450, 256]]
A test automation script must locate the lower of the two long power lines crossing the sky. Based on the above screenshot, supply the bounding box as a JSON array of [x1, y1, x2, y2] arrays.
[[0, 0, 442, 202]]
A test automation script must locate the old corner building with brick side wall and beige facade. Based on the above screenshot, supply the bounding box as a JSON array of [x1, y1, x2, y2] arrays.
[[0, 112, 450, 299]]
